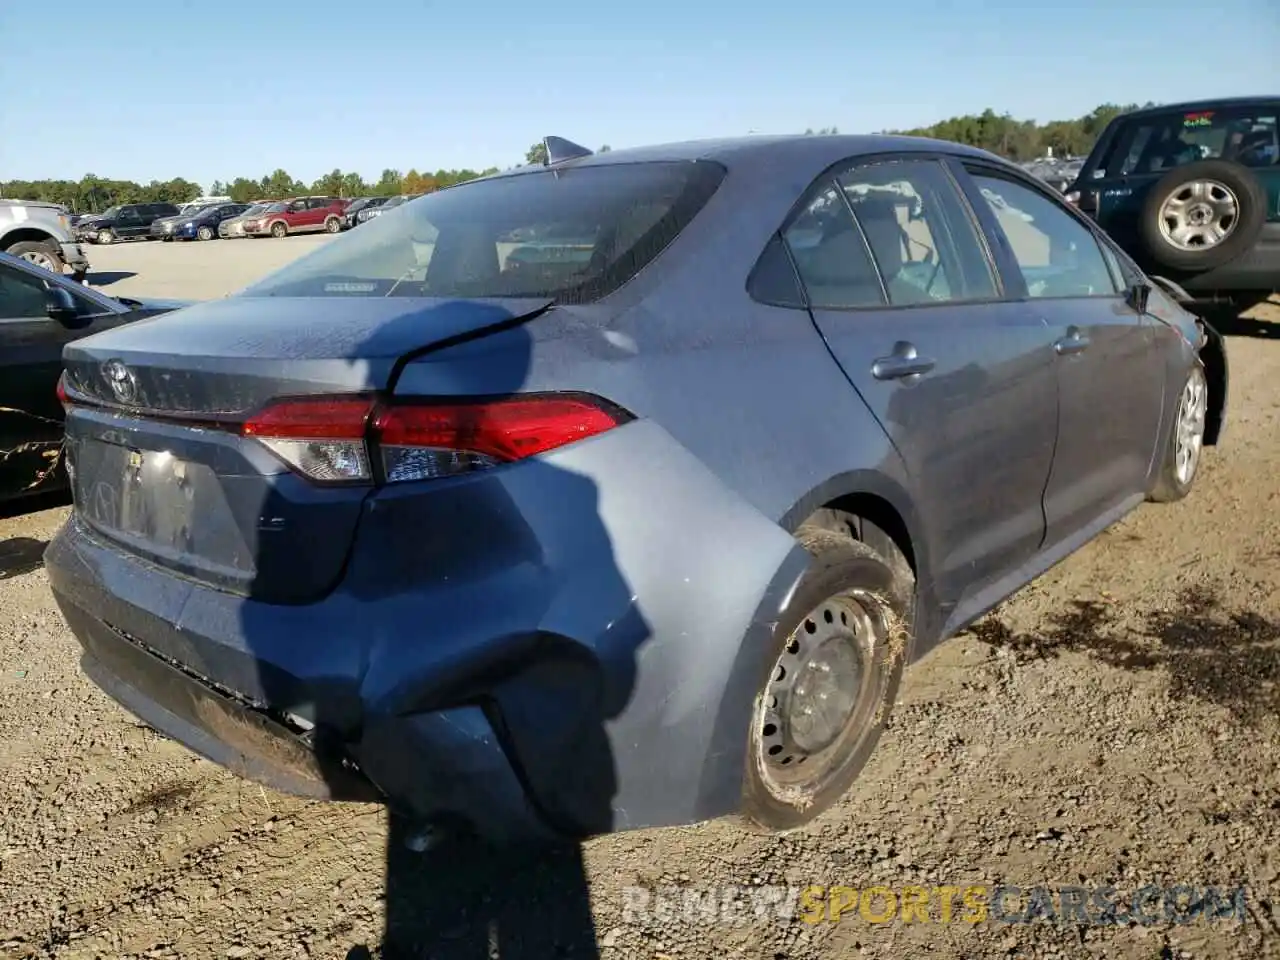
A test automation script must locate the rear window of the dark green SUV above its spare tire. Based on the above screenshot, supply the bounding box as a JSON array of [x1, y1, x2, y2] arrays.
[[1093, 105, 1280, 177]]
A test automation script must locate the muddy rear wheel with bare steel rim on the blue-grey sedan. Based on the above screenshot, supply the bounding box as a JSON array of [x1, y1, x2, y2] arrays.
[[741, 527, 910, 831]]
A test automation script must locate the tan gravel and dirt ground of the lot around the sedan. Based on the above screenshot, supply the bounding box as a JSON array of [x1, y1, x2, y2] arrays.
[[0, 238, 1280, 960]]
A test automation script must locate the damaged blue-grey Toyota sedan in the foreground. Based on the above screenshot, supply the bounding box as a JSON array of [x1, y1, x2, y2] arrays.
[[45, 136, 1226, 841]]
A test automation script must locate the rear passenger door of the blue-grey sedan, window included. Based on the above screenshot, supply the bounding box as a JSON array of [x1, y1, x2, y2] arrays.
[[785, 159, 1057, 609]]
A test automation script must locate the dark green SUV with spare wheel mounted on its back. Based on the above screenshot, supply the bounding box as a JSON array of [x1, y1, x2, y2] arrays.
[[1066, 96, 1280, 297]]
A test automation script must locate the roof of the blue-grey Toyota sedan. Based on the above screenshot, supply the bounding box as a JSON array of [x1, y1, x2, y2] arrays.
[[483, 133, 1009, 177]]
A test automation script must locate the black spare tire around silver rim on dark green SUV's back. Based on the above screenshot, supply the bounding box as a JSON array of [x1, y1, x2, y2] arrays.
[[1138, 160, 1267, 273]]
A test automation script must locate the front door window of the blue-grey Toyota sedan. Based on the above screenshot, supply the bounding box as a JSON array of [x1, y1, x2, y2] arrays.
[[973, 173, 1120, 297]]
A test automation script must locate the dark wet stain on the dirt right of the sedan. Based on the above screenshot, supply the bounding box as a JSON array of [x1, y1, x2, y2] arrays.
[[970, 585, 1280, 727]]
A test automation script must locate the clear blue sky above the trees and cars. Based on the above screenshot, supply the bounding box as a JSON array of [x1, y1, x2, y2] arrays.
[[0, 0, 1280, 188]]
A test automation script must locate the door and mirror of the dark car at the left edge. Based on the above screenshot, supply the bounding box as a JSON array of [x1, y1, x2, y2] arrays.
[[0, 264, 127, 499]]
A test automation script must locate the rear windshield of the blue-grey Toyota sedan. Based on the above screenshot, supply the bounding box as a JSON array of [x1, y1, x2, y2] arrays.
[[242, 161, 724, 303]]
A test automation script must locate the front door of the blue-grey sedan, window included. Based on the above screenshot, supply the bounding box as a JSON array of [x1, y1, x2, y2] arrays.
[[965, 163, 1165, 544]]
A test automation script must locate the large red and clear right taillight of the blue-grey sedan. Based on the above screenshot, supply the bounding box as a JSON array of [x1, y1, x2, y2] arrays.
[[242, 394, 626, 483]]
